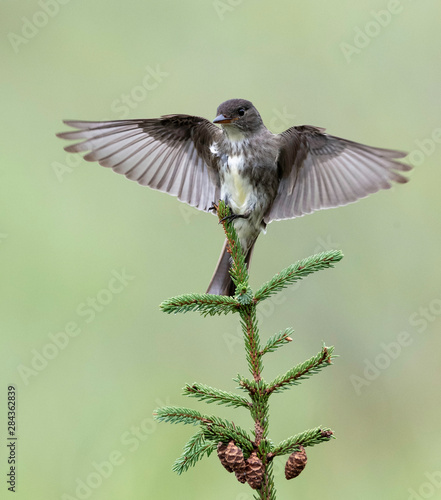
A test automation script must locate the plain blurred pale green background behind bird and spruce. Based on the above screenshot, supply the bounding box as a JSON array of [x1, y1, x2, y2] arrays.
[[0, 0, 441, 500]]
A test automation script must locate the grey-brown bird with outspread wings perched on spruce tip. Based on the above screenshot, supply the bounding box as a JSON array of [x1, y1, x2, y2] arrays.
[[57, 99, 411, 295]]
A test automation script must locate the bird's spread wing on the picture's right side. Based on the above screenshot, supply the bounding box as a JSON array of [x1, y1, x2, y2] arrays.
[[265, 125, 411, 223]]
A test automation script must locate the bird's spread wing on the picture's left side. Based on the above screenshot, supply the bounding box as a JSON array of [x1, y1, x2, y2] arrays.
[[57, 115, 222, 210]]
